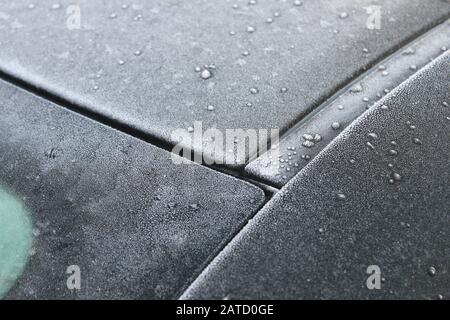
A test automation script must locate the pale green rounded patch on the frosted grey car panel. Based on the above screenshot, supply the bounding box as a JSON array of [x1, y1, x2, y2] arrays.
[[0, 187, 33, 298]]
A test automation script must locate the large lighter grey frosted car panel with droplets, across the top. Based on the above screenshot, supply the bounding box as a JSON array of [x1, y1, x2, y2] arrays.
[[0, 0, 450, 167]]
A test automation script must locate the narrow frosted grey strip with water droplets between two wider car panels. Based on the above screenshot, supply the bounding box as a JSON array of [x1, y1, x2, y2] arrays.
[[245, 21, 450, 187]]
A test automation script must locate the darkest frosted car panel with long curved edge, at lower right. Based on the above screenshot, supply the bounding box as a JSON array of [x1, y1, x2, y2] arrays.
[[183, 51, 450, 299]]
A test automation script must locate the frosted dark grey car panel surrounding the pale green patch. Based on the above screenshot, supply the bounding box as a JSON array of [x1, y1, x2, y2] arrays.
[[0, 81, 264, 299]]
